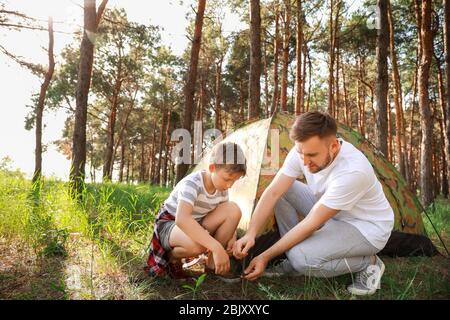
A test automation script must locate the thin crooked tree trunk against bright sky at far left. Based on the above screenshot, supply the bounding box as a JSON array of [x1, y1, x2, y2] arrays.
[[33, 17, 55, 183]]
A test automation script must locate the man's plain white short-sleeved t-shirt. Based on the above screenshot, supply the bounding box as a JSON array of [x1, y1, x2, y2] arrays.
[[281, 139, 394, 250]]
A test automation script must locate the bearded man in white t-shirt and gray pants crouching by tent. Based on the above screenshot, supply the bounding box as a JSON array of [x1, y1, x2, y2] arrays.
[[233, 111, 394, 295]]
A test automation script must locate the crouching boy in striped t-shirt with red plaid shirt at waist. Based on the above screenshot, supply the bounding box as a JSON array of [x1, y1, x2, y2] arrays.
[[147, 142, 247, 277]]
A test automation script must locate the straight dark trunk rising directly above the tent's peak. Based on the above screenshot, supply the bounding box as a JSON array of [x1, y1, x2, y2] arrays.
[[248, 0, 261, 119]]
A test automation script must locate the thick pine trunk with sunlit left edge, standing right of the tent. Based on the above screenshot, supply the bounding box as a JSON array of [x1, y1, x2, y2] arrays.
[[418, 0, 433, 206]]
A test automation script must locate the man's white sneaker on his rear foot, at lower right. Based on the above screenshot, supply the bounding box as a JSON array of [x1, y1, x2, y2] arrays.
[[347, 256, 385, 296]]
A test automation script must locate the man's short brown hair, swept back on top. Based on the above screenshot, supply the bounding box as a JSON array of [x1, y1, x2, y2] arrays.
[[289, 111, 337, 142]]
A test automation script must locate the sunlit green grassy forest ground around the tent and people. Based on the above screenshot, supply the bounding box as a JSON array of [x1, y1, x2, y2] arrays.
[[0, 171, 450, 299]]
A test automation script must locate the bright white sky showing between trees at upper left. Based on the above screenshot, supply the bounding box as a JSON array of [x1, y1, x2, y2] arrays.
[[0, 0, 246, 180]]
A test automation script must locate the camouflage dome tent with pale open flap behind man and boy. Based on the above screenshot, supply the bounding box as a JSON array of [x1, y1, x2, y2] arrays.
[[193, 113, 437, 256]]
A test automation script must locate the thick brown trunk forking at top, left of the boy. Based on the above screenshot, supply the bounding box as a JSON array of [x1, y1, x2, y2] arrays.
[[70, 0, 108, 196]]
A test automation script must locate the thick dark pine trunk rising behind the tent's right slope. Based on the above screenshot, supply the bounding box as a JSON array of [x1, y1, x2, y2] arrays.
[[376, 0, 389, 156]]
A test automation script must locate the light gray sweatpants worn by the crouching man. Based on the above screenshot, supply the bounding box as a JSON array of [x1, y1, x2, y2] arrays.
[[275, 181, 379, 277]]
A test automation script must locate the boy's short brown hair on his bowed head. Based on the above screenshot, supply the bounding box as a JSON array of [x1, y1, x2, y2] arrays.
[[210, 142, 247, 176]]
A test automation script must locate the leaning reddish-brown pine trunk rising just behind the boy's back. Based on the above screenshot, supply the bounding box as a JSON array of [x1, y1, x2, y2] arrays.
[[176, 0, 206, 182]]
